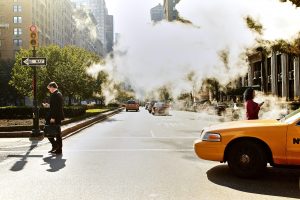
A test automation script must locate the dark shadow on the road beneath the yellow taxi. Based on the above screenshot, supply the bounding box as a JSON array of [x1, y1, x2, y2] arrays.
[[207, 165, 300, 199]]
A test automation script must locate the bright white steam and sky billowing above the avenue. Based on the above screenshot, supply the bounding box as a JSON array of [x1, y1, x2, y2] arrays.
[[90, 0, 300, 100]]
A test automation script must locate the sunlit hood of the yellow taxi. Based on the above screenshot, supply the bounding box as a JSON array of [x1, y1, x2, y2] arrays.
[[204, 119, 285, 132]]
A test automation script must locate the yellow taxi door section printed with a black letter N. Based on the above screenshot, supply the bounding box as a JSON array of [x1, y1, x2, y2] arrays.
[[286, 120, 300, 165]]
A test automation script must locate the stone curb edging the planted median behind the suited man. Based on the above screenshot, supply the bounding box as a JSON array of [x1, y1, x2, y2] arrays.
[[0, 108, 124, 138]]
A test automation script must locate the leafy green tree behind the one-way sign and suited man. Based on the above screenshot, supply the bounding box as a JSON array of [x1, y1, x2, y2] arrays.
[[10, 45, 102, 105]]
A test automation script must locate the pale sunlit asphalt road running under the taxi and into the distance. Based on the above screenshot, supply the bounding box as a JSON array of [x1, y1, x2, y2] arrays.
[[0, 109, 300, 200]]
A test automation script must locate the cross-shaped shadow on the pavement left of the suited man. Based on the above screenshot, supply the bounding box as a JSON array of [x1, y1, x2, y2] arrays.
[[7, 140, 43, 172]]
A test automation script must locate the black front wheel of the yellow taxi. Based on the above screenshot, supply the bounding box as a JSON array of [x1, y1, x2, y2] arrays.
[[227, 141, 267, 178]]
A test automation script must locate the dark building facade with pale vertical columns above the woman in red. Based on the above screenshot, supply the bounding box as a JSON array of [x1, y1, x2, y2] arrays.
[[241, 51, 300, 101]]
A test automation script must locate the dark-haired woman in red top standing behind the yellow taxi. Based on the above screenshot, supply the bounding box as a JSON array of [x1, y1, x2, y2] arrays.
[[244, 88, 264, 120]]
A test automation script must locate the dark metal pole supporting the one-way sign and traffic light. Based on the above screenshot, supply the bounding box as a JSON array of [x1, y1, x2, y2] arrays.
[[32, 47, 41, 136]]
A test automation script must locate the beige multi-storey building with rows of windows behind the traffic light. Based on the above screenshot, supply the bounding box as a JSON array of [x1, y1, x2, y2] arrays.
[[0, 0, 74, 59]]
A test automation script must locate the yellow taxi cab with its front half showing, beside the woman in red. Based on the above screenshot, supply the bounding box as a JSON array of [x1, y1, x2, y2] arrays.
[[194, 109, 300, 178]]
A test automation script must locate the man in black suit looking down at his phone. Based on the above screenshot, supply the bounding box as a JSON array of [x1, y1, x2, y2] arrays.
[[43, 82, 64, 154]]
